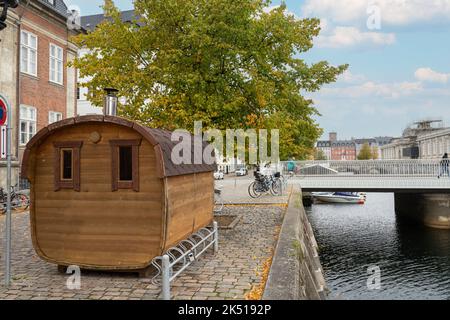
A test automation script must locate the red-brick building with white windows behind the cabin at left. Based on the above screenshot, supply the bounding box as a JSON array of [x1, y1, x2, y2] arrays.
[[0, 0, 78, 187]]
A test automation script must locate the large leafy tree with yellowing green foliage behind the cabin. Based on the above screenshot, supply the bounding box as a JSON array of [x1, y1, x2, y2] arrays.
[[73, 0, 347, 158]]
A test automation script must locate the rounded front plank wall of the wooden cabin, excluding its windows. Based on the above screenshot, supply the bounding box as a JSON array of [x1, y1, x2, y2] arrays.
[[31, 124, 164, 269]]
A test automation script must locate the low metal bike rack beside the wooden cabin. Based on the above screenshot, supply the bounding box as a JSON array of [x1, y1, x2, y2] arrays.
[[152, 222, 219, 300]]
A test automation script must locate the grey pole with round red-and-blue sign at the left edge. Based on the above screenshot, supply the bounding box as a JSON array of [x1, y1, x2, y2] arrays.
[[0, 94, 11, 286]]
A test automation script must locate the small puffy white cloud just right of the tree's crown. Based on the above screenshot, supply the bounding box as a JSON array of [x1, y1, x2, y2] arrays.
[[316, 27, 396, 48]]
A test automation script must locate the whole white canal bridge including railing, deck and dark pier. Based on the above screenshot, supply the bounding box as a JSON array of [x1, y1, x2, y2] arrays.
[[282, 160, 450, 229]]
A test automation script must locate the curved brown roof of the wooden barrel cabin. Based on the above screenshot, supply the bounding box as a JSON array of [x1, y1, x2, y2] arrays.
[[20, 115, 217, 178]]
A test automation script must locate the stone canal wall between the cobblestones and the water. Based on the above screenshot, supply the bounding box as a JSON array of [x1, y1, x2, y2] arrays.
[[263, 187, 326, 300]]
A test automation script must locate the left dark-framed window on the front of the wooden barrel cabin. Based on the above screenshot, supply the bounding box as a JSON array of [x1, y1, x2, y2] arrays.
[[53, 141, 83, 191]]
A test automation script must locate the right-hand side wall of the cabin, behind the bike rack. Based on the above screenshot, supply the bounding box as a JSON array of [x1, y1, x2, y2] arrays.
[[165, 172, 214, 249]]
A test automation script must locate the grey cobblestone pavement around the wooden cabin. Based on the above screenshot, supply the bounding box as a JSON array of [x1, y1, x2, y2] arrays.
[[0, 206, 284, 300]]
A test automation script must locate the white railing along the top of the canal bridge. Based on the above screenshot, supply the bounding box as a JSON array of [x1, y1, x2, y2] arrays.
[[280, 160, 448, 178]]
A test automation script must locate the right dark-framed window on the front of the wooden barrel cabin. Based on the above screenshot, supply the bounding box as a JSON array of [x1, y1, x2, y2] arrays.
[[110, 140, 141, 192]]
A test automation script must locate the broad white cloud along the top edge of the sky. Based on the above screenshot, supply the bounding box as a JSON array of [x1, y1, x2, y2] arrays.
[[302, 0, 450, 27]]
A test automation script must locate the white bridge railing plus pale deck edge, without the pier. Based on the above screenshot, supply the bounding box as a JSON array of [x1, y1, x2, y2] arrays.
[[280, 160, 450, 190]]
